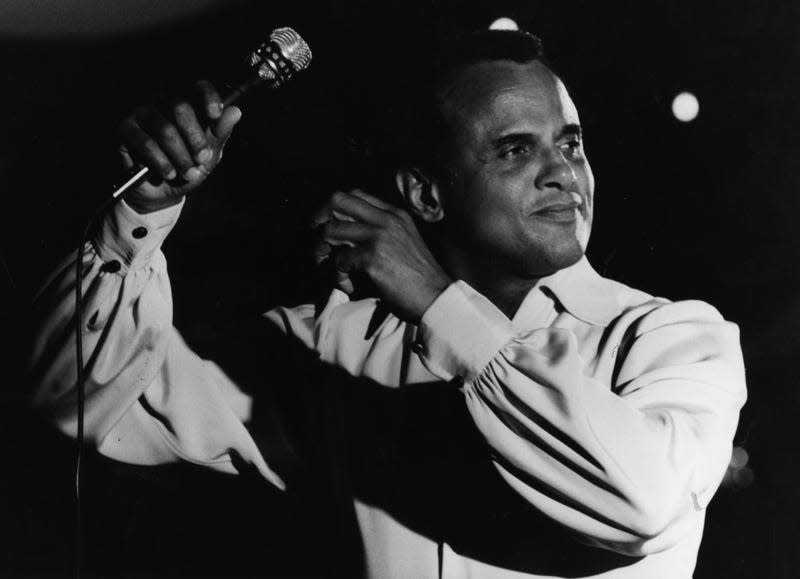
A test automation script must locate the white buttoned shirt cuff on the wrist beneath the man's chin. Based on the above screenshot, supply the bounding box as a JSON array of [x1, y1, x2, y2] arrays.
[[416, 281, 516, 381]]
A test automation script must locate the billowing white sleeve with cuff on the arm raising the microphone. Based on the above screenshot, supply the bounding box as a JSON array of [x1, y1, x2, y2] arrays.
[[28, 201, 283, 486]]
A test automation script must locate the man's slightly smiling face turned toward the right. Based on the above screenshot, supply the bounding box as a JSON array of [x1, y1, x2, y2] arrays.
[[432, 61, 594, 278]]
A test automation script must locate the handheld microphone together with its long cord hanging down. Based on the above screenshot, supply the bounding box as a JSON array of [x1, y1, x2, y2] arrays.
[[74, 27, 311, 577]]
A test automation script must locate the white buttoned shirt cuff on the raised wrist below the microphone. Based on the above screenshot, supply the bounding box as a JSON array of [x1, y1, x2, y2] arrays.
[[94, 197, 186, 273]]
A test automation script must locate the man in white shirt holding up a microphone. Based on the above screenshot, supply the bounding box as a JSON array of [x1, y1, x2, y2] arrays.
[[33, 31, 745, 578]]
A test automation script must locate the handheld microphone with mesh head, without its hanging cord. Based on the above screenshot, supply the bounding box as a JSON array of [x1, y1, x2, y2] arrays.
[[111, 26, 311, 200]]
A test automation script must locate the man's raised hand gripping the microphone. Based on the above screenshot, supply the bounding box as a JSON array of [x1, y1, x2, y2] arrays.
[[119, 81, 242, 213]]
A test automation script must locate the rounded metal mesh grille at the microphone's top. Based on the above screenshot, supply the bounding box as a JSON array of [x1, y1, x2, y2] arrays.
[[250, 27, 311, 87]]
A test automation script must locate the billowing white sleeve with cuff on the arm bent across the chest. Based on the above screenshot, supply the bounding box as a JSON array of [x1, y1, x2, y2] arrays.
[[418, 282, 746, 555]]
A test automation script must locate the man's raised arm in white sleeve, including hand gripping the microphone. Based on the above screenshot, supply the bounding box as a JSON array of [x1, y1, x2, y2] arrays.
[[29, 84, 282, 486]]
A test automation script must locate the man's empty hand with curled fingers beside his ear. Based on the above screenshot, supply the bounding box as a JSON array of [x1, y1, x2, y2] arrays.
[[314, 189, 451, 323]]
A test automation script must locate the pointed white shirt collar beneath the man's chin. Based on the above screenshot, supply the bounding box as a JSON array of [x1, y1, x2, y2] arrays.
[[534, 256, 620, 325]]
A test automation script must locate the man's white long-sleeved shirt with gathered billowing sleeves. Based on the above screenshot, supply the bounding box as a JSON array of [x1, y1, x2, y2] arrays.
[[32, 203, 745, 579]]
